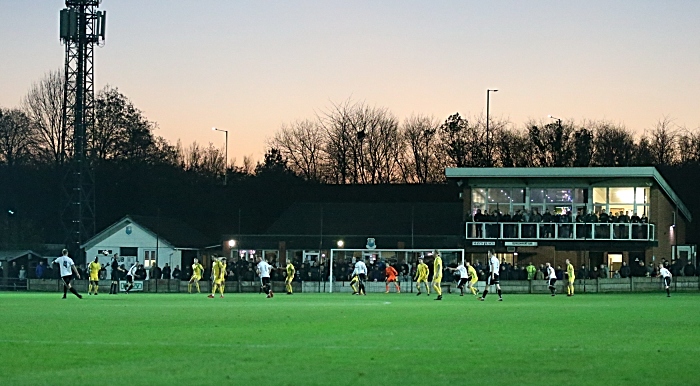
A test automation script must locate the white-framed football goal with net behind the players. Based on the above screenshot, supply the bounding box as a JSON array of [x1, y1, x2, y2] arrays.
[[328, 248, 464, 292]]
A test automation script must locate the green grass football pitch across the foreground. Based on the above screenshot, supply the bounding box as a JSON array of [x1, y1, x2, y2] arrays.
[[0, 293, 700, 386]]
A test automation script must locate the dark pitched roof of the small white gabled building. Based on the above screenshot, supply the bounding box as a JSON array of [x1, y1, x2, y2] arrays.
[[81, 215, 213, 248]]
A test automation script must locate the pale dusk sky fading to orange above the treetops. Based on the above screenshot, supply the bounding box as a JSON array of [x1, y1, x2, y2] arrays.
[[0, 0, 700, 165]]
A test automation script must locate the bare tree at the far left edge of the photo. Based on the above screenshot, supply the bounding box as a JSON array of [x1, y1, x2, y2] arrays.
[[0, 108, 34, 166]]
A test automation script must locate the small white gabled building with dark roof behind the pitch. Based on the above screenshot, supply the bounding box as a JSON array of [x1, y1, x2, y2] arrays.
[[81, 215, 211, 273]]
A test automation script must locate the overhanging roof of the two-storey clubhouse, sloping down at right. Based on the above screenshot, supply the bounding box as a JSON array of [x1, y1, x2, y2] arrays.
[[445, 166, 693, 221]]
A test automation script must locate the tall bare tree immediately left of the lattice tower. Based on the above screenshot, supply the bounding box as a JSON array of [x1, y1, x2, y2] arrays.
[[22, 70, 67, 165]]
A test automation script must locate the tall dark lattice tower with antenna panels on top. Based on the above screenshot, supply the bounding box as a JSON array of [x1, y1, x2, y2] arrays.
[[60, 0, 107, 261]]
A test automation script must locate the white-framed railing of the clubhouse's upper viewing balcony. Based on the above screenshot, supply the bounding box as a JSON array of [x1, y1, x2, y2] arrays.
[[466, 222, 656, 241]]
